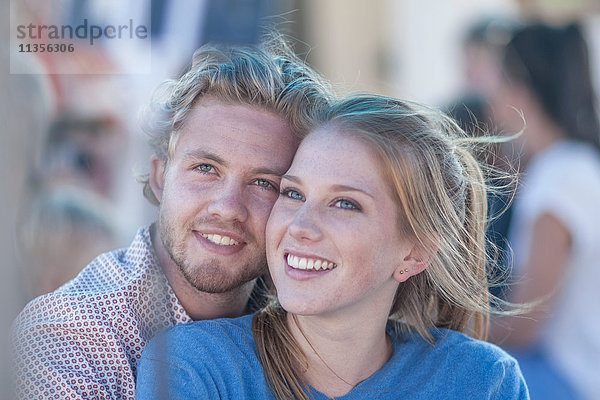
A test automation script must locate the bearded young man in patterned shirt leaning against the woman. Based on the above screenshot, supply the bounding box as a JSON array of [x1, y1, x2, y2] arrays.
[[15, 41, 330, 399]]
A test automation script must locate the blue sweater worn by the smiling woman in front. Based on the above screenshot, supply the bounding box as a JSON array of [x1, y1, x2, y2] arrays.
[[136, 315, 529, 400]]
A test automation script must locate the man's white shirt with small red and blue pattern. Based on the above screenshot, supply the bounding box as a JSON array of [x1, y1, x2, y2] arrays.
[[14, 226, 191, 400]]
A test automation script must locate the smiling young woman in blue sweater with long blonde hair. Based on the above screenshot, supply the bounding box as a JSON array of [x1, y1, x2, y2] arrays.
[[137, 96, 528, 399]]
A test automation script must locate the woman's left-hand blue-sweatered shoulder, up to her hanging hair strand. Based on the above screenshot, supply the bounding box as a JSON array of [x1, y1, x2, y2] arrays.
[[136, 315, 271, 399]]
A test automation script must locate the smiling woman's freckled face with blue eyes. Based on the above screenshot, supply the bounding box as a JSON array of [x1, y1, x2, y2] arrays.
[[266, 127, 418, 316]]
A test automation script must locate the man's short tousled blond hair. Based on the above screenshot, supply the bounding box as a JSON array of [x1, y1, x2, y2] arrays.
[[139, 31, 333, 205]]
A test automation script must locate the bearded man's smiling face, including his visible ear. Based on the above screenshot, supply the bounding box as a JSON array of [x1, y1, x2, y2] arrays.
[[151, 99, 297, 293]]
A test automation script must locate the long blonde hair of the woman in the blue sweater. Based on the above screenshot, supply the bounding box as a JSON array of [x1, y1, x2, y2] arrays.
[[252, 95, 506, 399]]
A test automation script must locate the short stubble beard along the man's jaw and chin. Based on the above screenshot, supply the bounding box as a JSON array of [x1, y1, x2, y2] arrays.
[[158, 206, 267, 293]]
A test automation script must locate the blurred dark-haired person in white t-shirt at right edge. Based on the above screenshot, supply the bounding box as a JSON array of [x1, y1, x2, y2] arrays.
[[492, 24, 600, 399]]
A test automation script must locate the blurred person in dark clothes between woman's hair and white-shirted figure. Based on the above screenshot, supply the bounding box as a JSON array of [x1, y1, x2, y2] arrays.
[[446, 18, 518, 298]]
